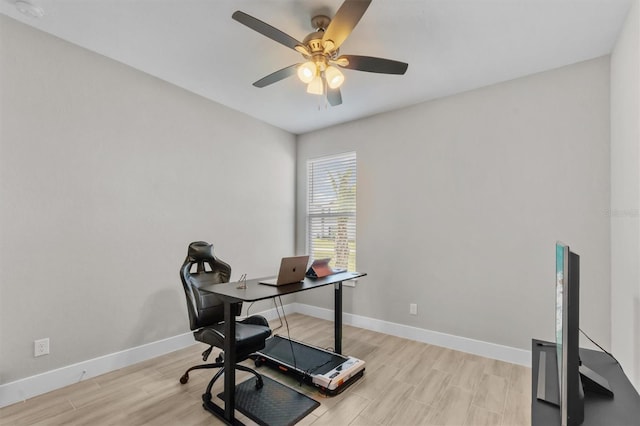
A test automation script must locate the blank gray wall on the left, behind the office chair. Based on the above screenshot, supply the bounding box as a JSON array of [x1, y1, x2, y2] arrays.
[[0, 15, 295, 384]]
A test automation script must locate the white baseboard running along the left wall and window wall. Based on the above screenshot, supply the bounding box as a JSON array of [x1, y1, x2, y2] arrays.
[[0, 303, 531, 407]]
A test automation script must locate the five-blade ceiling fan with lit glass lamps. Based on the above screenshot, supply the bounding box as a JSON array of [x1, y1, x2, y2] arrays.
[[231, 0, 409, 106]]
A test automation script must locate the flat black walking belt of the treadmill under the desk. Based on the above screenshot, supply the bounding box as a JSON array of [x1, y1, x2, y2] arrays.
[[260, 336, 348, 374]]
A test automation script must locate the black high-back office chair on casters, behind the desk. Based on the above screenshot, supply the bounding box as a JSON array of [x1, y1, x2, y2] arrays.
[[180, 241, 271, 399]]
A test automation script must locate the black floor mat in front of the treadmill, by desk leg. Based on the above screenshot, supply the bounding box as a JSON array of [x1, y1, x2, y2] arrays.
[[218, 375, 320, 426]]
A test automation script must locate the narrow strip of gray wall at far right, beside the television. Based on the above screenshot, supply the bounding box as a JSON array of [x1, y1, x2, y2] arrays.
[[611, 0, 640, 389]]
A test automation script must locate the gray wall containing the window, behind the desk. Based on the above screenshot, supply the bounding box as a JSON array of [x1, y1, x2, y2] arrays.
[[296, 57, 610, 349]]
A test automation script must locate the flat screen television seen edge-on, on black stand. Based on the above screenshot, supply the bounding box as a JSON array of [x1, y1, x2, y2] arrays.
[[538, 242, 613, 426]]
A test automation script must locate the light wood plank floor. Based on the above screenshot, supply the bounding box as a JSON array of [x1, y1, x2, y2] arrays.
[[0, 314, 531, 426]]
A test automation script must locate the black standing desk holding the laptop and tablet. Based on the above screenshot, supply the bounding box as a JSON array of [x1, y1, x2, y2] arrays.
[[201, 272, 367, 424]]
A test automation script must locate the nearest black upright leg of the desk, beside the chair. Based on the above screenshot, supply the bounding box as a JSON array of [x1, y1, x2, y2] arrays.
[[224, 302, 236, 424]]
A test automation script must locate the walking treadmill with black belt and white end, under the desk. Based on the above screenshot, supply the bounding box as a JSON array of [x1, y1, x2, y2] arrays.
[[254, 335, 365, 395]]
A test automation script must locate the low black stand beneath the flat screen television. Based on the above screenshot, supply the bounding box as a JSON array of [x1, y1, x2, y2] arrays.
[[531, 339, 640, 426]]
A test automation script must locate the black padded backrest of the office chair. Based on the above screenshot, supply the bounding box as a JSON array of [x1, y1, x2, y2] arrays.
[[180, 241, 242, 330]]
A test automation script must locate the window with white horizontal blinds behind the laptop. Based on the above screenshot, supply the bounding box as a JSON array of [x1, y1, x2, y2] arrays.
[[307, 152, 357, 271]]
